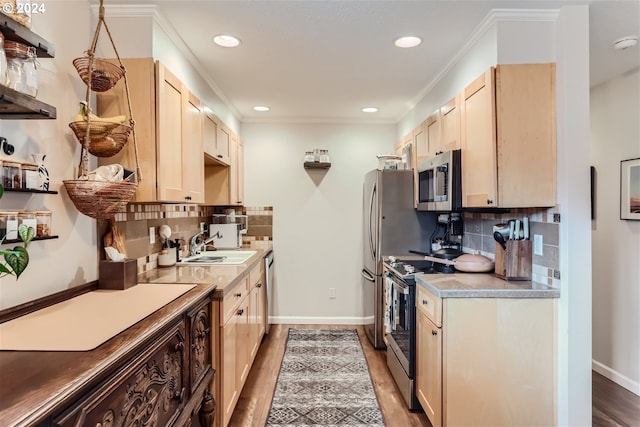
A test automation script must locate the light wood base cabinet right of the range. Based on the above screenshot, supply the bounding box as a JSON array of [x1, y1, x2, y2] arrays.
[[416, 286, 557, 427]]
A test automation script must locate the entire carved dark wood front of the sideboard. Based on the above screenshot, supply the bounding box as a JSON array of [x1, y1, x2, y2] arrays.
[[53, 298, 215, 427]]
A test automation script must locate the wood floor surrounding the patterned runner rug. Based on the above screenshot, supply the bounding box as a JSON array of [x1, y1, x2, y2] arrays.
[[228, 325, 431, 427]]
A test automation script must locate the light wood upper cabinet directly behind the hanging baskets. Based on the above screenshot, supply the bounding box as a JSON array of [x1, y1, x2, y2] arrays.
[[97, 58, 204, 203]]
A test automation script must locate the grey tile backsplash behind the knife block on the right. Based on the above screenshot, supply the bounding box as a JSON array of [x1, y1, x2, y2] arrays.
[[462, 208, 560, 288]]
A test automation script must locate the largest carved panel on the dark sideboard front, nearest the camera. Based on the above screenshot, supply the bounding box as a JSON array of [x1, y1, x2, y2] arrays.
[[53, 320, 187, 427]]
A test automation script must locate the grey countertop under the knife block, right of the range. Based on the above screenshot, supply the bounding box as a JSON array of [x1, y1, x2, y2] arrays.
[[415, 273, 560, 298]]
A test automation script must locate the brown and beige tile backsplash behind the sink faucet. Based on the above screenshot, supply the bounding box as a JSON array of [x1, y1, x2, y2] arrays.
[[98, 203, 273, 273]]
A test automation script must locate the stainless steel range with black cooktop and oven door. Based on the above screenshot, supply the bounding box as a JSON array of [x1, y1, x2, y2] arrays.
[[384, 257, 438, 411]]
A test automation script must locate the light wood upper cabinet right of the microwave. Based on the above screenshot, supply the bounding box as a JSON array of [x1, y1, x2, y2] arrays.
[[462, 63, 557, 208]]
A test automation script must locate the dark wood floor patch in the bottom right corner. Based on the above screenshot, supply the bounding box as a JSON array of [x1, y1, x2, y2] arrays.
[[591, 371, 640, 427]]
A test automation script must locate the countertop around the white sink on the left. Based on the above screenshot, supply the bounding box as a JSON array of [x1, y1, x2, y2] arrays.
[[138, 241, 273, 299]]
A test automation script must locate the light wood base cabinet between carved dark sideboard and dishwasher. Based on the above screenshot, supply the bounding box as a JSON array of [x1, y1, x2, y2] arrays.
[[213, 263, 265, 427]]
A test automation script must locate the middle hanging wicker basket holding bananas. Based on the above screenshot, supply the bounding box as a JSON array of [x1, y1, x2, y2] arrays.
[[69, 121, 132, 157]]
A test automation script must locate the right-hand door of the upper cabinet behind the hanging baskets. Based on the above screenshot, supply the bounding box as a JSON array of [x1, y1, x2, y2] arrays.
[[182, 90, 204, 203]]
